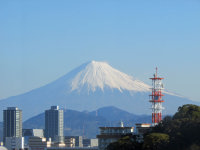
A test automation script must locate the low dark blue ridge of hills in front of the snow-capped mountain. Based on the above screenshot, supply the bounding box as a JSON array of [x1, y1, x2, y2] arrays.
[[23, 107, 151, 138]]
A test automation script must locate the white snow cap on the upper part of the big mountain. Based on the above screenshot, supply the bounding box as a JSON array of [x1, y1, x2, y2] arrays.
[[71, 61, 150, 92]]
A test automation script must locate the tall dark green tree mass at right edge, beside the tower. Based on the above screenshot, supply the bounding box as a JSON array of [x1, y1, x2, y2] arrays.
[[152, 104, 200, 150]]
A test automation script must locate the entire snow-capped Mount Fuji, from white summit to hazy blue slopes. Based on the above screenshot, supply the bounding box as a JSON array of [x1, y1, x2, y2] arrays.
[[0, 61, 199, 120]]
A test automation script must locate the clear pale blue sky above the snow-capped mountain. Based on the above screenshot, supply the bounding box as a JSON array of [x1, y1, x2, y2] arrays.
[[0, 0, 200, 101]]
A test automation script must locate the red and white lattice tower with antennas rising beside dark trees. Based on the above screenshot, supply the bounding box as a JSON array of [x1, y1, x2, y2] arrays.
[[149, 67, 164, 126]]
